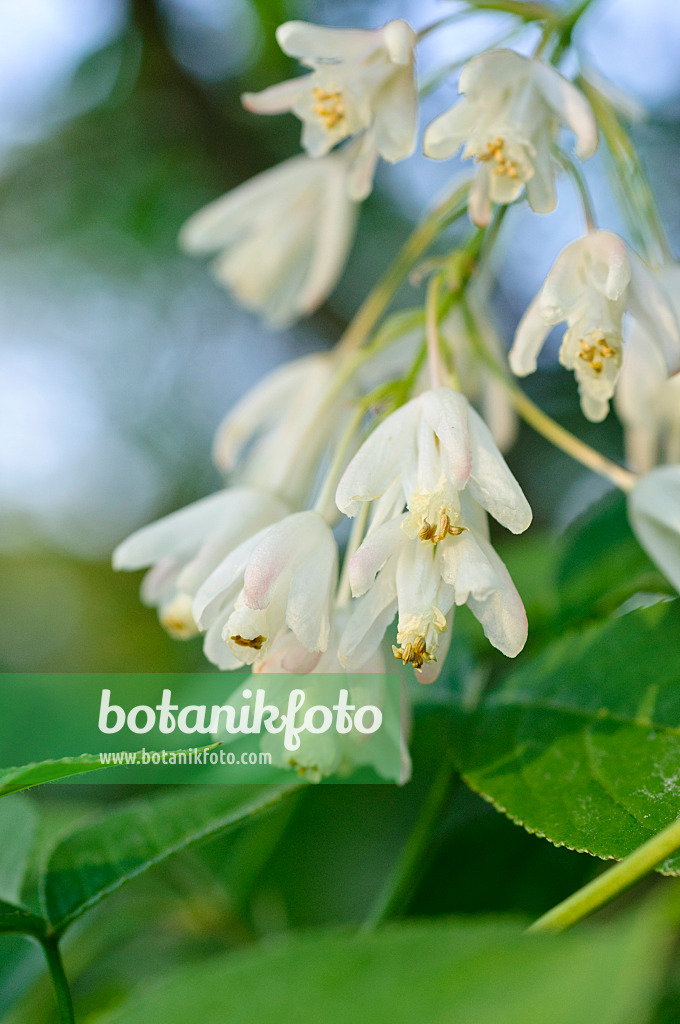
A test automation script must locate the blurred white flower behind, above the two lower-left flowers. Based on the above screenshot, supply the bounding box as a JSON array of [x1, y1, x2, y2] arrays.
[[213, 352, 352, 508]]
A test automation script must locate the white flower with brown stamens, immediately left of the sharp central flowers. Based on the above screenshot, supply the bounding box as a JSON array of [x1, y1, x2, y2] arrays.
[[194, 511, 338, 669]]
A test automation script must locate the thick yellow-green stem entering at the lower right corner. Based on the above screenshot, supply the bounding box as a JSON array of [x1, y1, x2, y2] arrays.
[[529, 818, 680, 933]]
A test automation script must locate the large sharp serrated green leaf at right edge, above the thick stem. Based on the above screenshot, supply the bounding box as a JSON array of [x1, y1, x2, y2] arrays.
[[458, 601, 680, 873]]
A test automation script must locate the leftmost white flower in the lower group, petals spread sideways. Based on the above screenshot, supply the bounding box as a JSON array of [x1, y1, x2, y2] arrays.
[[113, 487, 288, 639]]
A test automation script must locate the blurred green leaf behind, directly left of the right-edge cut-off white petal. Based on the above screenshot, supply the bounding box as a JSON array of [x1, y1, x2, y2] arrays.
[[557, 492, 671, 618]]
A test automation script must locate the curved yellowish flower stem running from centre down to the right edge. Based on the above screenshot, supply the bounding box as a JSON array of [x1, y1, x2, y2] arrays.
[[463, 301, 637, 493]]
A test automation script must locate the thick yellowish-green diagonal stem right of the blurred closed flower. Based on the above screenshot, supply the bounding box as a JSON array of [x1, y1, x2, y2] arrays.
[[336, 180, 470, 355]]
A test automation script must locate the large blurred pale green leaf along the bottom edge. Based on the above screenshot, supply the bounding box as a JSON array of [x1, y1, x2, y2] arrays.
[[93, 919, 666, 1024]]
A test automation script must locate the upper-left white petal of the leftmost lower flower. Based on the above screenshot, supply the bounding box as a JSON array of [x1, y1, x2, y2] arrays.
[[113, 488, 239, 569]]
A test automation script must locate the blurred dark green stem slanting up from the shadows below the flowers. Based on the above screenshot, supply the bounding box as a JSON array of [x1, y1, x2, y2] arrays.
[[362, 759, 455, 932]]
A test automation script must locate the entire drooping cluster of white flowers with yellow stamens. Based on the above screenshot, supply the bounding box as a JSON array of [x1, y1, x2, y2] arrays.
[[114, 8, 680, 779]]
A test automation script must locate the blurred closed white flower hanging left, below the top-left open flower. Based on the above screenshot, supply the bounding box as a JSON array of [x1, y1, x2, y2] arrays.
[[179, 153, 357, 326]]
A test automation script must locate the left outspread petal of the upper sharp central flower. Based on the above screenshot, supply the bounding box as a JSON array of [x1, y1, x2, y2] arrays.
[[335, 399, 421, 516]]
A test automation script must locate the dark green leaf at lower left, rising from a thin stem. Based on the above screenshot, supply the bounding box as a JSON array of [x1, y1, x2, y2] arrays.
[[42, 783, 298, 933]]
